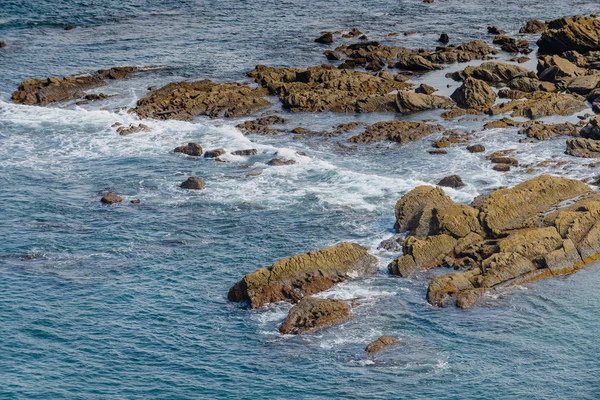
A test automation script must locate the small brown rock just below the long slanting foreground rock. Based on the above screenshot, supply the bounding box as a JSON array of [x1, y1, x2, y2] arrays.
[[279, 297, 352, 335]]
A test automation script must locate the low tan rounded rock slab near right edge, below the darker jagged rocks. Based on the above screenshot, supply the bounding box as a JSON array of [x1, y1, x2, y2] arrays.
[[490, 92, 587, 119]]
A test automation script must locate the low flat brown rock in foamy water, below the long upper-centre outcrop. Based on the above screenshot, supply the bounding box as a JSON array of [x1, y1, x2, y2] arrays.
[[348, 120, 444, 144]]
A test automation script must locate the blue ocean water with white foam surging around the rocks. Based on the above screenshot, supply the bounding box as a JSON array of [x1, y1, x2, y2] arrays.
[[0, 0, 600, 399]]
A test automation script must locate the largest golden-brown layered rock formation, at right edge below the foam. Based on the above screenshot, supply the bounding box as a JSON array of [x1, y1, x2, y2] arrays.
[[388, 175, 600, 308]]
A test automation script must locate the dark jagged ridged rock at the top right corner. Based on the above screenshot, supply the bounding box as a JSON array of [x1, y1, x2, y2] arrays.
[[537, 16, 600, 54]]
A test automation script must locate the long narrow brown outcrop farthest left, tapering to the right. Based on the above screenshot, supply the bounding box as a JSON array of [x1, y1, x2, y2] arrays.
[[12, 67, 144, 106]]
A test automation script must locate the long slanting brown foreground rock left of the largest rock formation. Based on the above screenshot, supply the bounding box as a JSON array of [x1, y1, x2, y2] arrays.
[[227, 242, 377, 308]]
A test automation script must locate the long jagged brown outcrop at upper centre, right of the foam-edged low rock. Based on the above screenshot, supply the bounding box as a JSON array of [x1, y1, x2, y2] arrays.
[[248, 65, 412, 113]]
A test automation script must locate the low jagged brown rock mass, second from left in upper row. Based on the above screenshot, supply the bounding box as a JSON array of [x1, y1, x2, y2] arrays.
[[134, 80, 271, 121]]
